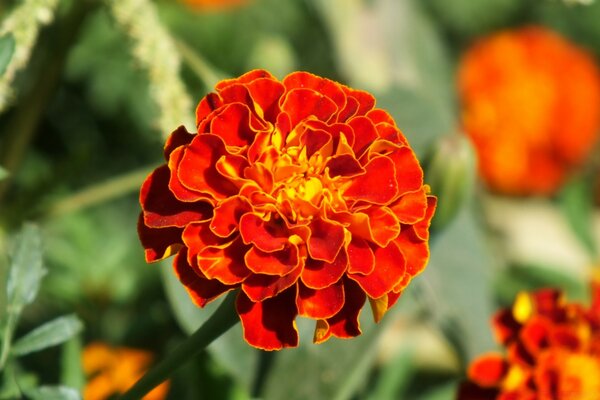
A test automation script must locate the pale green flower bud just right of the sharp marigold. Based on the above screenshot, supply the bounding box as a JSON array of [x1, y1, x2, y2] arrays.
[[424, 133, 476, 231]]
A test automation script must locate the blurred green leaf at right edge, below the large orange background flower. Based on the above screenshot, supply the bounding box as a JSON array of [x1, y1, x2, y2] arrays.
[[559, 177, 598, 259]]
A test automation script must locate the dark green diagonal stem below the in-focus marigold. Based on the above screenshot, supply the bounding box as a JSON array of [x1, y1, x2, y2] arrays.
[[120, 292, 239, 400]]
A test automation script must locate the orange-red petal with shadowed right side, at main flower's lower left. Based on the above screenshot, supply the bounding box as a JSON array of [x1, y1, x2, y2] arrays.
[[197, 237, 251, 285]]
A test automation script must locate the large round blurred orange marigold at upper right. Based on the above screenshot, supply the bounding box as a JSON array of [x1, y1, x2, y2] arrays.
[[458, 26, 600, 195]]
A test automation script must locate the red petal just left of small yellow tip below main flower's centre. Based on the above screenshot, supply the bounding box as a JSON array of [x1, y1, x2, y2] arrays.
[[240, 213, 290, 252]]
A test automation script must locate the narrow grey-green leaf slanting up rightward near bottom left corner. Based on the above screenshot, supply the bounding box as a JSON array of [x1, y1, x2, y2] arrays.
[[12, 315, 83, 356]]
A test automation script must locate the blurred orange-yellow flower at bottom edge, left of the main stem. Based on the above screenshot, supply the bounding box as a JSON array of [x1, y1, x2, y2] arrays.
[[82, 342, 169, 400]]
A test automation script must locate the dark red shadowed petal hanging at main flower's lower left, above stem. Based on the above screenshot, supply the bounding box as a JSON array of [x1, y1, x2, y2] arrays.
[[173, 247, 233, 307]]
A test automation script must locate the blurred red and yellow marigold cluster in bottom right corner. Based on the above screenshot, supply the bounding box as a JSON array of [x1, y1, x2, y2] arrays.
[[458, 283, 600, 400]]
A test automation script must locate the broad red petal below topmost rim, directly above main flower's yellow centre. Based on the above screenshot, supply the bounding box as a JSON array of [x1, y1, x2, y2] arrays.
[[281, 89, 337, 127]]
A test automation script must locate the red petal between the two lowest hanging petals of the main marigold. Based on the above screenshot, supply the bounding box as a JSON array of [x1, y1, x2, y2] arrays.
[[296, 280, 344, 319]]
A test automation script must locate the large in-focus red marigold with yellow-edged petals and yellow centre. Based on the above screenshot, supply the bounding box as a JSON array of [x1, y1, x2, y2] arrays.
[[139, 70, 436, 350]]
